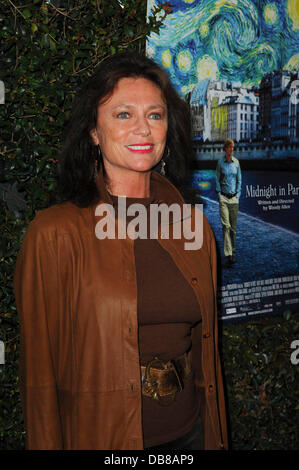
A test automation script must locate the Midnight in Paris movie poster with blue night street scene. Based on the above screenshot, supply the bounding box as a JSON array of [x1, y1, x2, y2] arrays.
[[147, 0, 299, 321]]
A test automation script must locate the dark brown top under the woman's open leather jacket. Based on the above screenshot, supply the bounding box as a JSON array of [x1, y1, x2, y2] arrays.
[[112, 196, 201, 447]]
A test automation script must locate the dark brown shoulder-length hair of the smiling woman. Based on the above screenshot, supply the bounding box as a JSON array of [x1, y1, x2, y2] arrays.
[[58, 53, 192, 207]]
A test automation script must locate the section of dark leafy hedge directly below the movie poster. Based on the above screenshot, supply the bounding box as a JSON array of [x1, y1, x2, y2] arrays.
[[221, 311, 299, 450]]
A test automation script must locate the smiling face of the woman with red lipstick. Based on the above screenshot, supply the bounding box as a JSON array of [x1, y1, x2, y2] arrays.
[[91, 77, 168, 181]]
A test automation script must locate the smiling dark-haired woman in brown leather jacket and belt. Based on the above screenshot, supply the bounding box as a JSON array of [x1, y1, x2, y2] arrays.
[[15, 54, 227, 449]]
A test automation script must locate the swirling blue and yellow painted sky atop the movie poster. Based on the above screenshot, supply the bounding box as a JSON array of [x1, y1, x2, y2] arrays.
[[147, 0, 299, 95]]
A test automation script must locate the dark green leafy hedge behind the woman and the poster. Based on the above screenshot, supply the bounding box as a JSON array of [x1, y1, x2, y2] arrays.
[[0, 0, 299, 449]]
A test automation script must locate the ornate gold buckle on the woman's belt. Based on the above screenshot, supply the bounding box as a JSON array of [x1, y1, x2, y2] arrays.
[[143, 357, 183, 406]]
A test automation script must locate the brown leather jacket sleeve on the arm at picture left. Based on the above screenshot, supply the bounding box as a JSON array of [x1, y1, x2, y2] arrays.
[[14, 218, 62, 449]]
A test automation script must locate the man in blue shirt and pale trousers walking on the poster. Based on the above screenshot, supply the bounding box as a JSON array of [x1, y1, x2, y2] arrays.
[[216, 139, 242, 266]]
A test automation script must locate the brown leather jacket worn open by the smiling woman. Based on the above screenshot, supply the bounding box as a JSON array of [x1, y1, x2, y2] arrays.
[[14, 172, 227, 450]]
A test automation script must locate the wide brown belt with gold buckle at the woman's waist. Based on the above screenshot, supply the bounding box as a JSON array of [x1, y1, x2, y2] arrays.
[[140, 353, 191, 406]]
